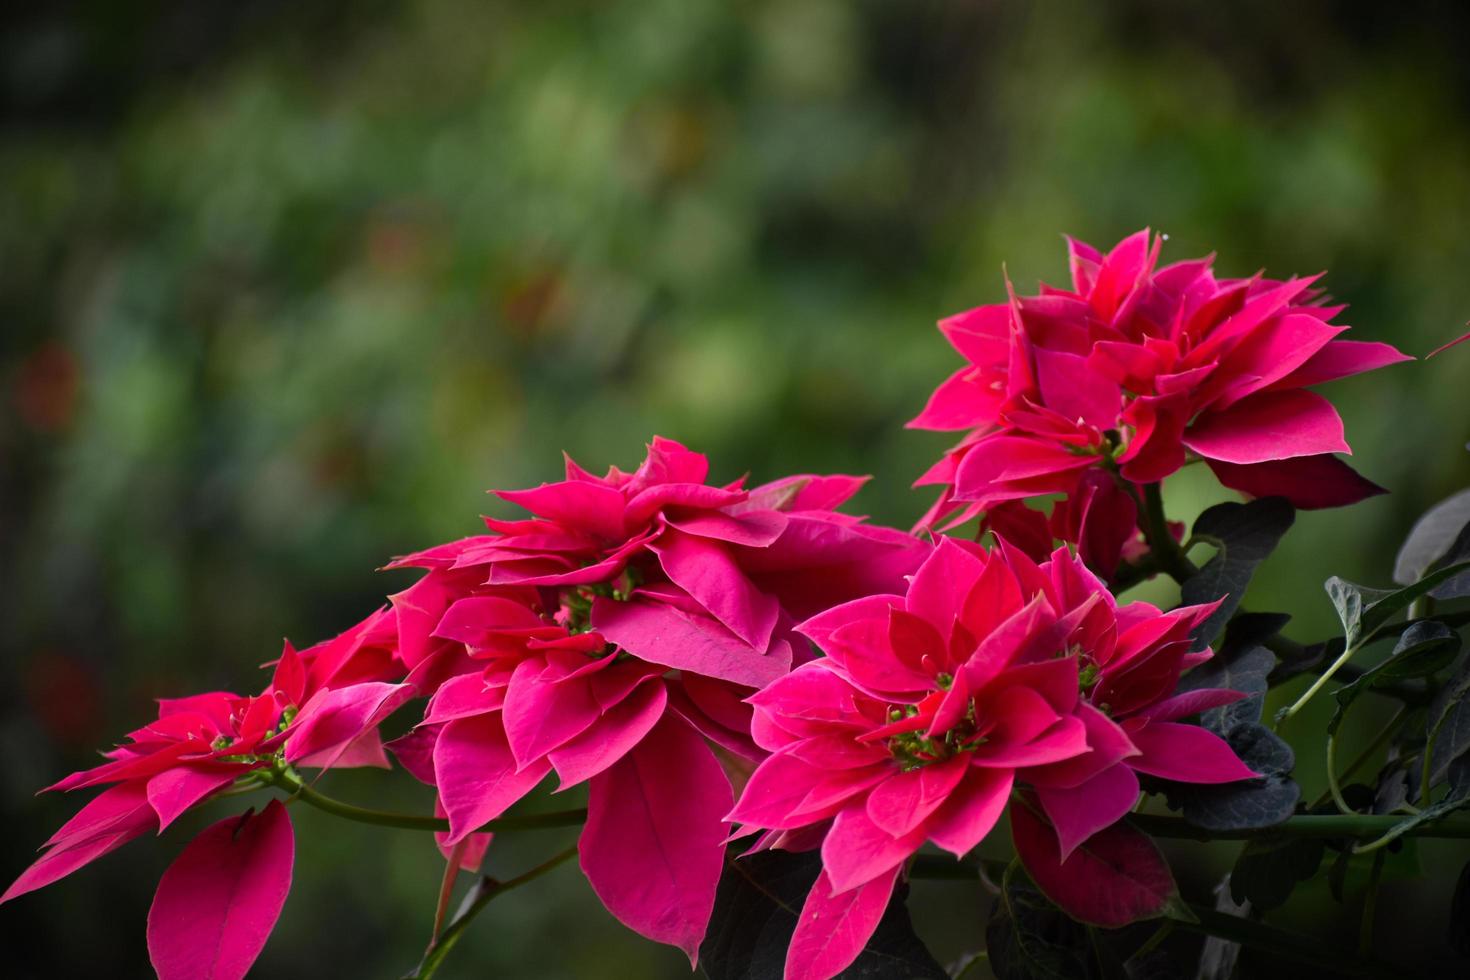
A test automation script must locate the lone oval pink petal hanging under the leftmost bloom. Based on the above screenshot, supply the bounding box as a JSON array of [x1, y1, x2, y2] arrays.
[[148, 799, 295, 980]]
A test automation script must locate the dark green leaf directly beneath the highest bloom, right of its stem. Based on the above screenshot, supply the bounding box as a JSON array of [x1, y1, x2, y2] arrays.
[[1179, 497, 1297, 649]]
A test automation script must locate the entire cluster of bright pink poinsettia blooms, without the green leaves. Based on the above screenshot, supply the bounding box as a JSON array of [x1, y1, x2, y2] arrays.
[[0, 232, 1404, 980]]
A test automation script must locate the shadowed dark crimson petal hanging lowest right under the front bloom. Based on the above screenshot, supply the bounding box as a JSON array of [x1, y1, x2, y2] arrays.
[[1010, 802, 1179, 929]]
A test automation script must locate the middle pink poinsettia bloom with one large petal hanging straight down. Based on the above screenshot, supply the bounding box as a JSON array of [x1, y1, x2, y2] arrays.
[[392, 438, 928, 962]]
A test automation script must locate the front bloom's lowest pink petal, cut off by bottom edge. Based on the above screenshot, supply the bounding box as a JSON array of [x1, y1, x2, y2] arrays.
[[785, 865, 898, 980]]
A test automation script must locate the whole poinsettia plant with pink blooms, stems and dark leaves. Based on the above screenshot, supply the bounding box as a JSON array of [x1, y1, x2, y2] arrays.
[[0, 231, 1470, 980]]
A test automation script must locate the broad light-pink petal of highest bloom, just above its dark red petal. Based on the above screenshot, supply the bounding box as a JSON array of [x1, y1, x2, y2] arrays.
[[1183, 389, 1352, 463]]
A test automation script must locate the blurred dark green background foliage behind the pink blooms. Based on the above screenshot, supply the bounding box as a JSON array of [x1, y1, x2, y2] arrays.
[[0, 0, 1470, 979]]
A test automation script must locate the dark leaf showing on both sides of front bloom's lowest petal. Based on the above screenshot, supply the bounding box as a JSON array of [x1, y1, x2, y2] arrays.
[[700, 851, 947, 980]]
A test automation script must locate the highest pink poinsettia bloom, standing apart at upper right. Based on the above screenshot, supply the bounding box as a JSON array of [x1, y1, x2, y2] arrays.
[[908, 229, 1410, 541]]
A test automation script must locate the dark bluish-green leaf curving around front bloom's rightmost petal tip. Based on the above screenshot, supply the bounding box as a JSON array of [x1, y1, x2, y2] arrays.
[[1166, 723, 1301, 830]]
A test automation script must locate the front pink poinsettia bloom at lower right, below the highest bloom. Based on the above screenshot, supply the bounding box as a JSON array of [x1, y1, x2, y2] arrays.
[[729, 538, 1254, 980]]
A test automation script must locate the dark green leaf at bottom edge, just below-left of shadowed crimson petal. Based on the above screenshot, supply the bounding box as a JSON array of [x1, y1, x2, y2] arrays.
[[985, 870, 1097, 980]]
